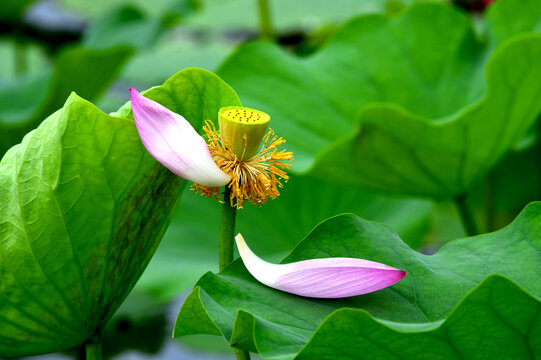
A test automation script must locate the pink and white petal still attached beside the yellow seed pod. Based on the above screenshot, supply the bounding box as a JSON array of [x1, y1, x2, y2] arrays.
[[130, 88, 231, 187]]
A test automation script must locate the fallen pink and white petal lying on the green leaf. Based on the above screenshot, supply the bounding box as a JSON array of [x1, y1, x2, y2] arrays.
[[235, 234, 406, 298]]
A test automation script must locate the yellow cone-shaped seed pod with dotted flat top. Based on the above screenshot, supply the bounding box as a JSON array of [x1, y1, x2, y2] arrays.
[[218, 106, 270, 160]]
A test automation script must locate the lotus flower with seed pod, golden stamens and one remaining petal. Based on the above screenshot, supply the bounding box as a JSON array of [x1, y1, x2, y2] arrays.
[[130, 88, 293, 208]]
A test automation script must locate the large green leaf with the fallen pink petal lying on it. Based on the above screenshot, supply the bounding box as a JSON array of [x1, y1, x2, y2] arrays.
[[175, 203, 541, 359]]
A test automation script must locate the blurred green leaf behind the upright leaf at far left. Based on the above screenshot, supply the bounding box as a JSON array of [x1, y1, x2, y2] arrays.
[[0, 47, 131, 155]]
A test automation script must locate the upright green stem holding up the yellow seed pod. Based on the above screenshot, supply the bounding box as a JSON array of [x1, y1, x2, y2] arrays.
[[219, 185, 250, 360]]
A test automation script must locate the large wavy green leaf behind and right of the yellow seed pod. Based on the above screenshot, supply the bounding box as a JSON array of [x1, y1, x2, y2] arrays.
[[219, 0, 541, 197]]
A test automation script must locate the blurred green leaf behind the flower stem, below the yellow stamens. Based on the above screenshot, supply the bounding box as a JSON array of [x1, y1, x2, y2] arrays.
[[136, 176, 433, 301]]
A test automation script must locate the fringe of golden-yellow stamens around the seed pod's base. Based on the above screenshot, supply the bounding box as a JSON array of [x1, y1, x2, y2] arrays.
[[192, 120, 293, 208]]
